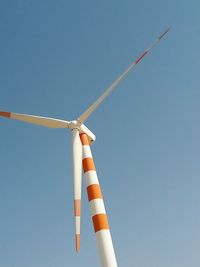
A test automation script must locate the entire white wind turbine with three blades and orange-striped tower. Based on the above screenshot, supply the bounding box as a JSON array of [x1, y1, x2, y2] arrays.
[[0, 28, 170, 267]]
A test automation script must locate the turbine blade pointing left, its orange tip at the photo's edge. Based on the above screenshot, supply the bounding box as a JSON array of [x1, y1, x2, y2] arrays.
[[0, 111, 70, 128]]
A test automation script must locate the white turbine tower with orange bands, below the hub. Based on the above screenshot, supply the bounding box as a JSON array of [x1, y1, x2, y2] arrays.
[[80, 133, 117, 267]]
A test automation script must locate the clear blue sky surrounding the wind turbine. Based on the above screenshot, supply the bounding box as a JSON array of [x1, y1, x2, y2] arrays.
[[0, 0, 200, 267]]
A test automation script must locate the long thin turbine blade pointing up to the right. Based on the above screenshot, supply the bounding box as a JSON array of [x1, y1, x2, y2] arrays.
[[78, 28, 170, 123]]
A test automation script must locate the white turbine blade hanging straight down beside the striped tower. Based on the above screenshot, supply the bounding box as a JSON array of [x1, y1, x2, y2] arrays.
[[72, 129, 82, 253]]
